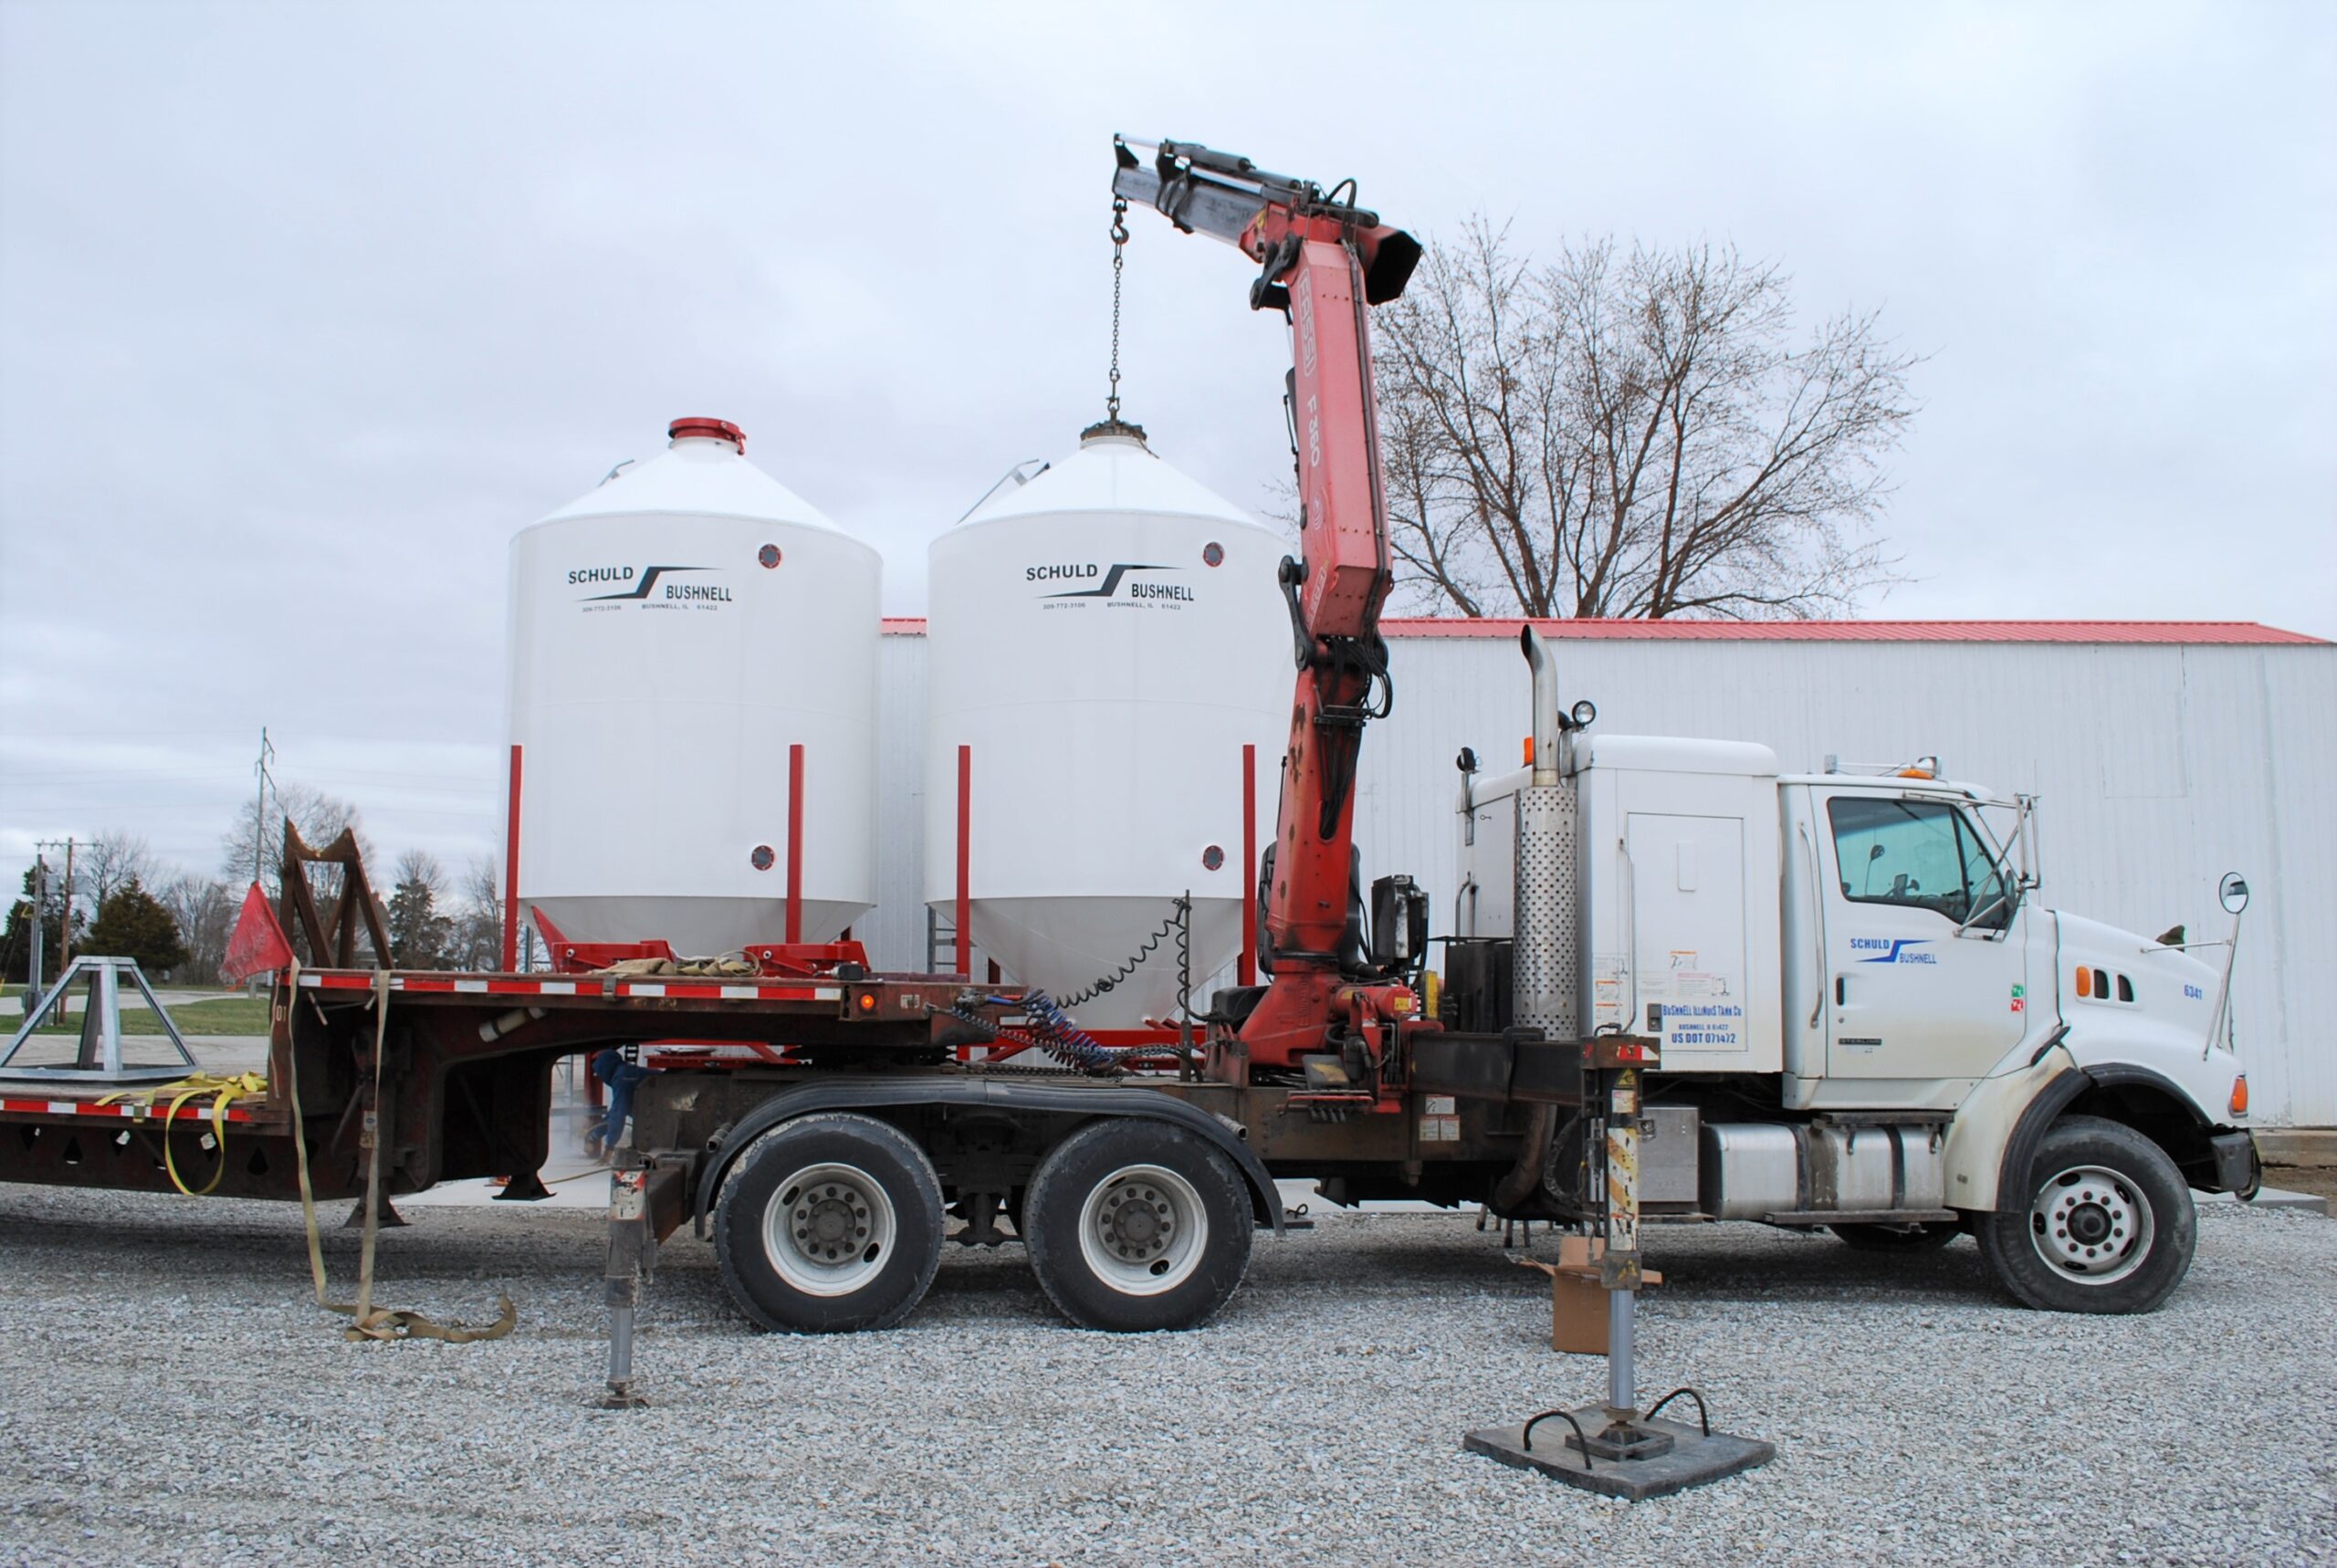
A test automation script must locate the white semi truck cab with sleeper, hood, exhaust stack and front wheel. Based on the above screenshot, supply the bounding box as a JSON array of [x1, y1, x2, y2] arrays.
[[1447, 629, 2258, 1311]]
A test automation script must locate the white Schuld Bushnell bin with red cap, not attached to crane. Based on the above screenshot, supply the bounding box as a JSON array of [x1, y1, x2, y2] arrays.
[[508, 418, 879, 954]]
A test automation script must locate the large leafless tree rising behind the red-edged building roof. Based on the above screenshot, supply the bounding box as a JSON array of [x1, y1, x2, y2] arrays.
[[1378, 217, 1916, 619]]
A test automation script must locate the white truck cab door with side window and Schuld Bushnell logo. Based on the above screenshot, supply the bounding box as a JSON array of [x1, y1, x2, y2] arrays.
[[1820, 789, 2028, 1082]]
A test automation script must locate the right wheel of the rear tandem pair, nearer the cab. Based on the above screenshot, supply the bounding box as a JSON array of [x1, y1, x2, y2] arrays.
[[1023, 1117, 1252, 1334]]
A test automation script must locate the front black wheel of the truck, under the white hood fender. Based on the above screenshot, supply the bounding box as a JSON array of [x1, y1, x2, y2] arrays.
[[1975, 1117, 2199, 1313]]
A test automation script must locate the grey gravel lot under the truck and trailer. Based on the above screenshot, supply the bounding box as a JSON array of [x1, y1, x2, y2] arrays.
[[0, 1187, 2337, 1563]]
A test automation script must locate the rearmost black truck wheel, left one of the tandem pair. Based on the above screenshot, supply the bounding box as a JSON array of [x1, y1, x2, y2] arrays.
[[715, 1113, 944, 1334]]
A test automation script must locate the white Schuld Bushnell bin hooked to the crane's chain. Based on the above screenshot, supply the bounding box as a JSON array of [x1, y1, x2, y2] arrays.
[[926, 425, 1293, 1029]]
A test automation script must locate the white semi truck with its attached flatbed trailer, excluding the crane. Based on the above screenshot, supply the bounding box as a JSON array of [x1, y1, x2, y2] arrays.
[[0, 629, 2258, 1364]]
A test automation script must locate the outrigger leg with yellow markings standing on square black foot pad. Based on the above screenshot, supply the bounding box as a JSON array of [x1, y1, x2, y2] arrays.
[[1463, 1035, 1776, 1502]]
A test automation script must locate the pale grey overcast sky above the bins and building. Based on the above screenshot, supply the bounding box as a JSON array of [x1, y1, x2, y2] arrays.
[[0, 0, 2337, 893]]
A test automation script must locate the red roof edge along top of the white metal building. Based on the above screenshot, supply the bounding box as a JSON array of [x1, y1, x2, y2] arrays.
[[884, 614, 2330, 647]]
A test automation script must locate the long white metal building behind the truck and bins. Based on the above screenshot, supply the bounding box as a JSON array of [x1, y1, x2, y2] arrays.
[[858, 619, 2337, 1126]]
